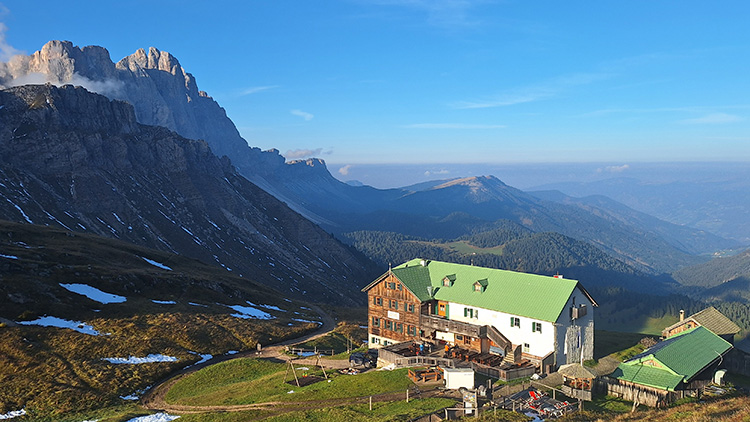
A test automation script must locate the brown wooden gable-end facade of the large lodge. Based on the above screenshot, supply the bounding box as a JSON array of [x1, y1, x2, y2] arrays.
[[367, 274, 422, 346]]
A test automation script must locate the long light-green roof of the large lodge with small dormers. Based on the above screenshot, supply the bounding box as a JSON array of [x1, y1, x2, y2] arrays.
[[388, 259, 588, 322]]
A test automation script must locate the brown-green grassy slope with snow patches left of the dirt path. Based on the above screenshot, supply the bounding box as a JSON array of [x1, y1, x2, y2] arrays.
[[0, 222, 318, 420]]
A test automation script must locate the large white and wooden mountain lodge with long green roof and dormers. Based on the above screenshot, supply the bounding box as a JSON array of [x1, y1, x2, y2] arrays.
[[362, 259, 598, 373]]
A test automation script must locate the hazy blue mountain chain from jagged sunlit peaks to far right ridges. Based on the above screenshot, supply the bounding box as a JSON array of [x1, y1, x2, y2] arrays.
[[0, 41, 739, 284]]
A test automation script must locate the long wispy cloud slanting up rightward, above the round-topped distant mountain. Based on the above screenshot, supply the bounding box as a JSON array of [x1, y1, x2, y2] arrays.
[[451, 73, 611, 109]]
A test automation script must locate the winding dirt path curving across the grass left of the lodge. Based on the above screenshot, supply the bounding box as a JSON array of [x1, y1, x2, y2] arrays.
[[141, 305, 349, 413]]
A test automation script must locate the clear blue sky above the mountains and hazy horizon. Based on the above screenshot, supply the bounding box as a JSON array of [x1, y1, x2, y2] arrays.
[[0, 0, 750, 185]]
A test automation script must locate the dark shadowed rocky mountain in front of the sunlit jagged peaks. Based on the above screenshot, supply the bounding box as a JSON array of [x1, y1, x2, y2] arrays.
[[0, 85, 372, 303]]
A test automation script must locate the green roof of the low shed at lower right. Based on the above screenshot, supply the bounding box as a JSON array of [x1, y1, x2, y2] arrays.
[[611, 327, 732, 390]]
